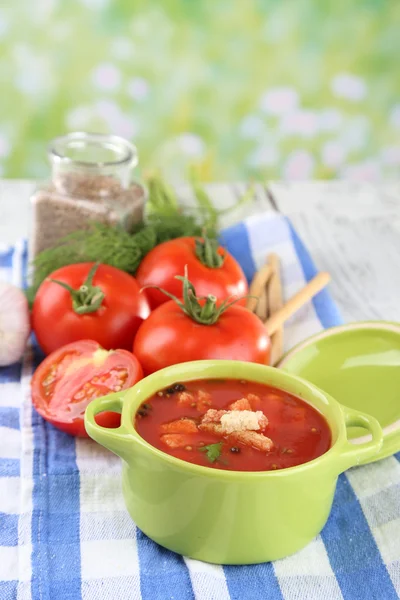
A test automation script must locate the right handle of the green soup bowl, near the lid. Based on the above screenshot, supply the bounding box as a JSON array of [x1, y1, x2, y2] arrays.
[[340, 407, 383, 472]]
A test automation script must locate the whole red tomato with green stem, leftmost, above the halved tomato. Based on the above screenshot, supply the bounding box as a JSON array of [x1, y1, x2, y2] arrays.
[[32, 263, 150, 354]]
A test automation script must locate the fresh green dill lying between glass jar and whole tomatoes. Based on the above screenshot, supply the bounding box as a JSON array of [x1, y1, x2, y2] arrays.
[[27, 174, 252, 303]]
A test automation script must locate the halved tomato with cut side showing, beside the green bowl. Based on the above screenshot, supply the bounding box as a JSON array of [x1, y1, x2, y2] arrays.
[[32, 340, 143, 437]]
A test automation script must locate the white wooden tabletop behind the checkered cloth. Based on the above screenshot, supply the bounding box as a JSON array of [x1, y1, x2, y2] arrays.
[[0, 180, 400, 321]]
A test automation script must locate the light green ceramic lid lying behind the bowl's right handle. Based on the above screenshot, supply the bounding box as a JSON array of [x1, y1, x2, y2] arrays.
[[279, 321, 400, 460]]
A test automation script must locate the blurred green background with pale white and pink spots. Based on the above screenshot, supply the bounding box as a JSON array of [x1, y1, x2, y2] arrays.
[[0, 0, 400, 181]]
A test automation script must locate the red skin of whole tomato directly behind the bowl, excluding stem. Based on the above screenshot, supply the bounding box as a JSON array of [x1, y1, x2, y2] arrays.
[[133, 300, 270, 375]]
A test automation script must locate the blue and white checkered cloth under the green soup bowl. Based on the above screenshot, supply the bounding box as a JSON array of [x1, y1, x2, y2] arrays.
[[0, 215, 400, 600]]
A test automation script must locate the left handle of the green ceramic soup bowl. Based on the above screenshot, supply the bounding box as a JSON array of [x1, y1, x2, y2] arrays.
[[85, 390, 132, 458]]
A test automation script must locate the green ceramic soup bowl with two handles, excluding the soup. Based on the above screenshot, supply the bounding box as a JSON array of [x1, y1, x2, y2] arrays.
[[85, 361, 382, 564]]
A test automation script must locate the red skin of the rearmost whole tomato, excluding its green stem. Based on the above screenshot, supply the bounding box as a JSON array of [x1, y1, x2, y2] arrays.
[[136, 237, 248, 310]]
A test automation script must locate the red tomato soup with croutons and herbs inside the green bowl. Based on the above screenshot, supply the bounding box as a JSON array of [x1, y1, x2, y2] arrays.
[[135, 379, 331, 471]]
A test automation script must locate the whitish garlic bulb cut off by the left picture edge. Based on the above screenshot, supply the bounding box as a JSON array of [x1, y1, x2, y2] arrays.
[[0, 282, 31, 367]]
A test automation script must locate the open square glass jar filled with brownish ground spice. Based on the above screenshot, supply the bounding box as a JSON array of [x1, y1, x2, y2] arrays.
[[31, 132, 146, 257]]
